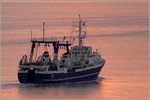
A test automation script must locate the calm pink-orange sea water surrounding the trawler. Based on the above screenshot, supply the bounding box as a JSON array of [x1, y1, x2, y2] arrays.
[[1, 2, 148, 100]]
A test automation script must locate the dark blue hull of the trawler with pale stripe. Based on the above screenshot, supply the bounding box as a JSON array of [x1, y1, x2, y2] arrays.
[[18, 65, 103, 84]]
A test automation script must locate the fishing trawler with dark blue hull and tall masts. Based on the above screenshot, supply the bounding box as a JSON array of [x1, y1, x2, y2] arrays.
[[18, 17, 105, 84]]
